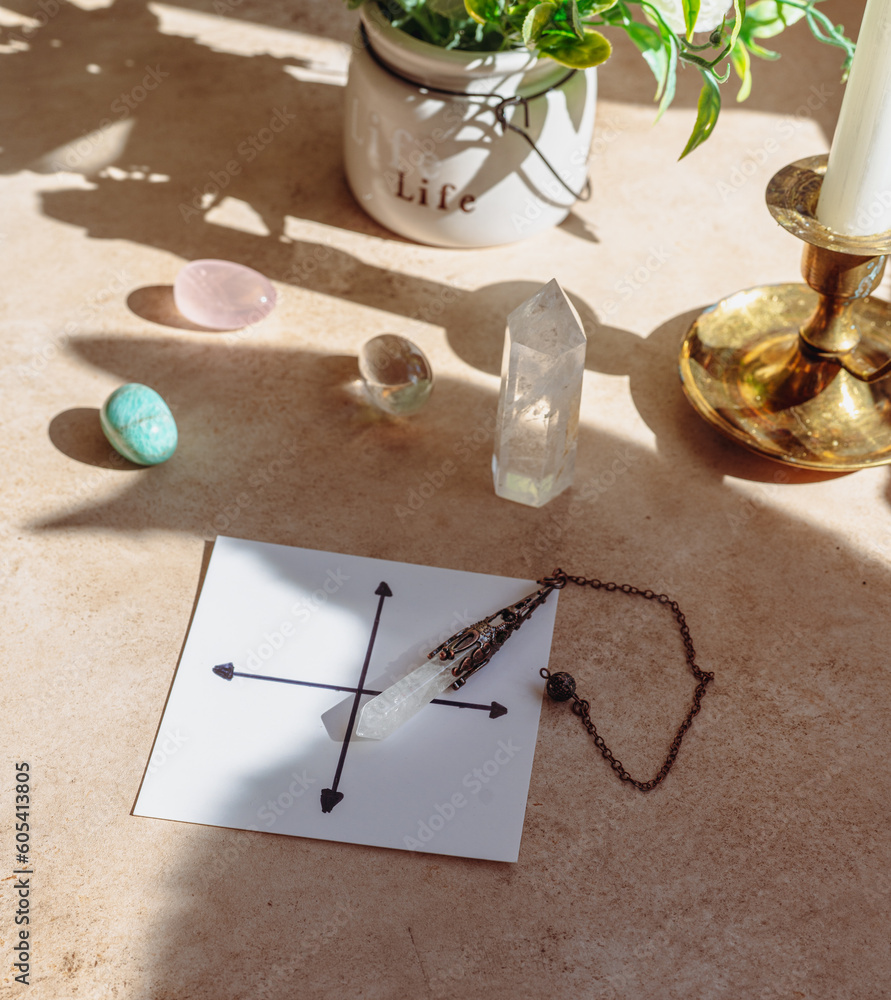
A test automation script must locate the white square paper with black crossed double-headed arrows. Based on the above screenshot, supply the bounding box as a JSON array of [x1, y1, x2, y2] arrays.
[[134, 537, 557, 861]]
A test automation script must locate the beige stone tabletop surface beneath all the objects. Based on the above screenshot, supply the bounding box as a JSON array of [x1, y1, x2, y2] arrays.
[[0, 0, 891, 1000]]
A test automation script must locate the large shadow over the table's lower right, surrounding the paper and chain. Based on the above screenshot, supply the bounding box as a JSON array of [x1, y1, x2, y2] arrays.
[[32, 328, 889, 1000]]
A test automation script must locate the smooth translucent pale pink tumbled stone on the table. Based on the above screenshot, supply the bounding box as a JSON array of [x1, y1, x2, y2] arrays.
[[173, 260, 276, 330]]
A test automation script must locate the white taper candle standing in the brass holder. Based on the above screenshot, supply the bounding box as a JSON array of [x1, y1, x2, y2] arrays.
[[817, 0, 891, 236]]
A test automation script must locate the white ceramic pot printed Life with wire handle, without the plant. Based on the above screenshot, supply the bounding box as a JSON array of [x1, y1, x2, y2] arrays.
[[344, 4, 597, 247]]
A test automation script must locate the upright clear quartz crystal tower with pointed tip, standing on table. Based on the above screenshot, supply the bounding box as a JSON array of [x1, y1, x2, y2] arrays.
[[492, 280, 586, 507]]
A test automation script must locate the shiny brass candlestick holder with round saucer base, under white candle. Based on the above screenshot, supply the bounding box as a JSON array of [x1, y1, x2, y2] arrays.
[[680, 156, 891, 472]]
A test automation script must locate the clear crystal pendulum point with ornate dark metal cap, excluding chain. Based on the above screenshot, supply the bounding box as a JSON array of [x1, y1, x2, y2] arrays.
[[356, 578, 562, 740]]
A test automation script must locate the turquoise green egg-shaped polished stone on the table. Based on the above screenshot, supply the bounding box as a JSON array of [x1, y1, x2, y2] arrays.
[[99, 382, 177, 465]]
